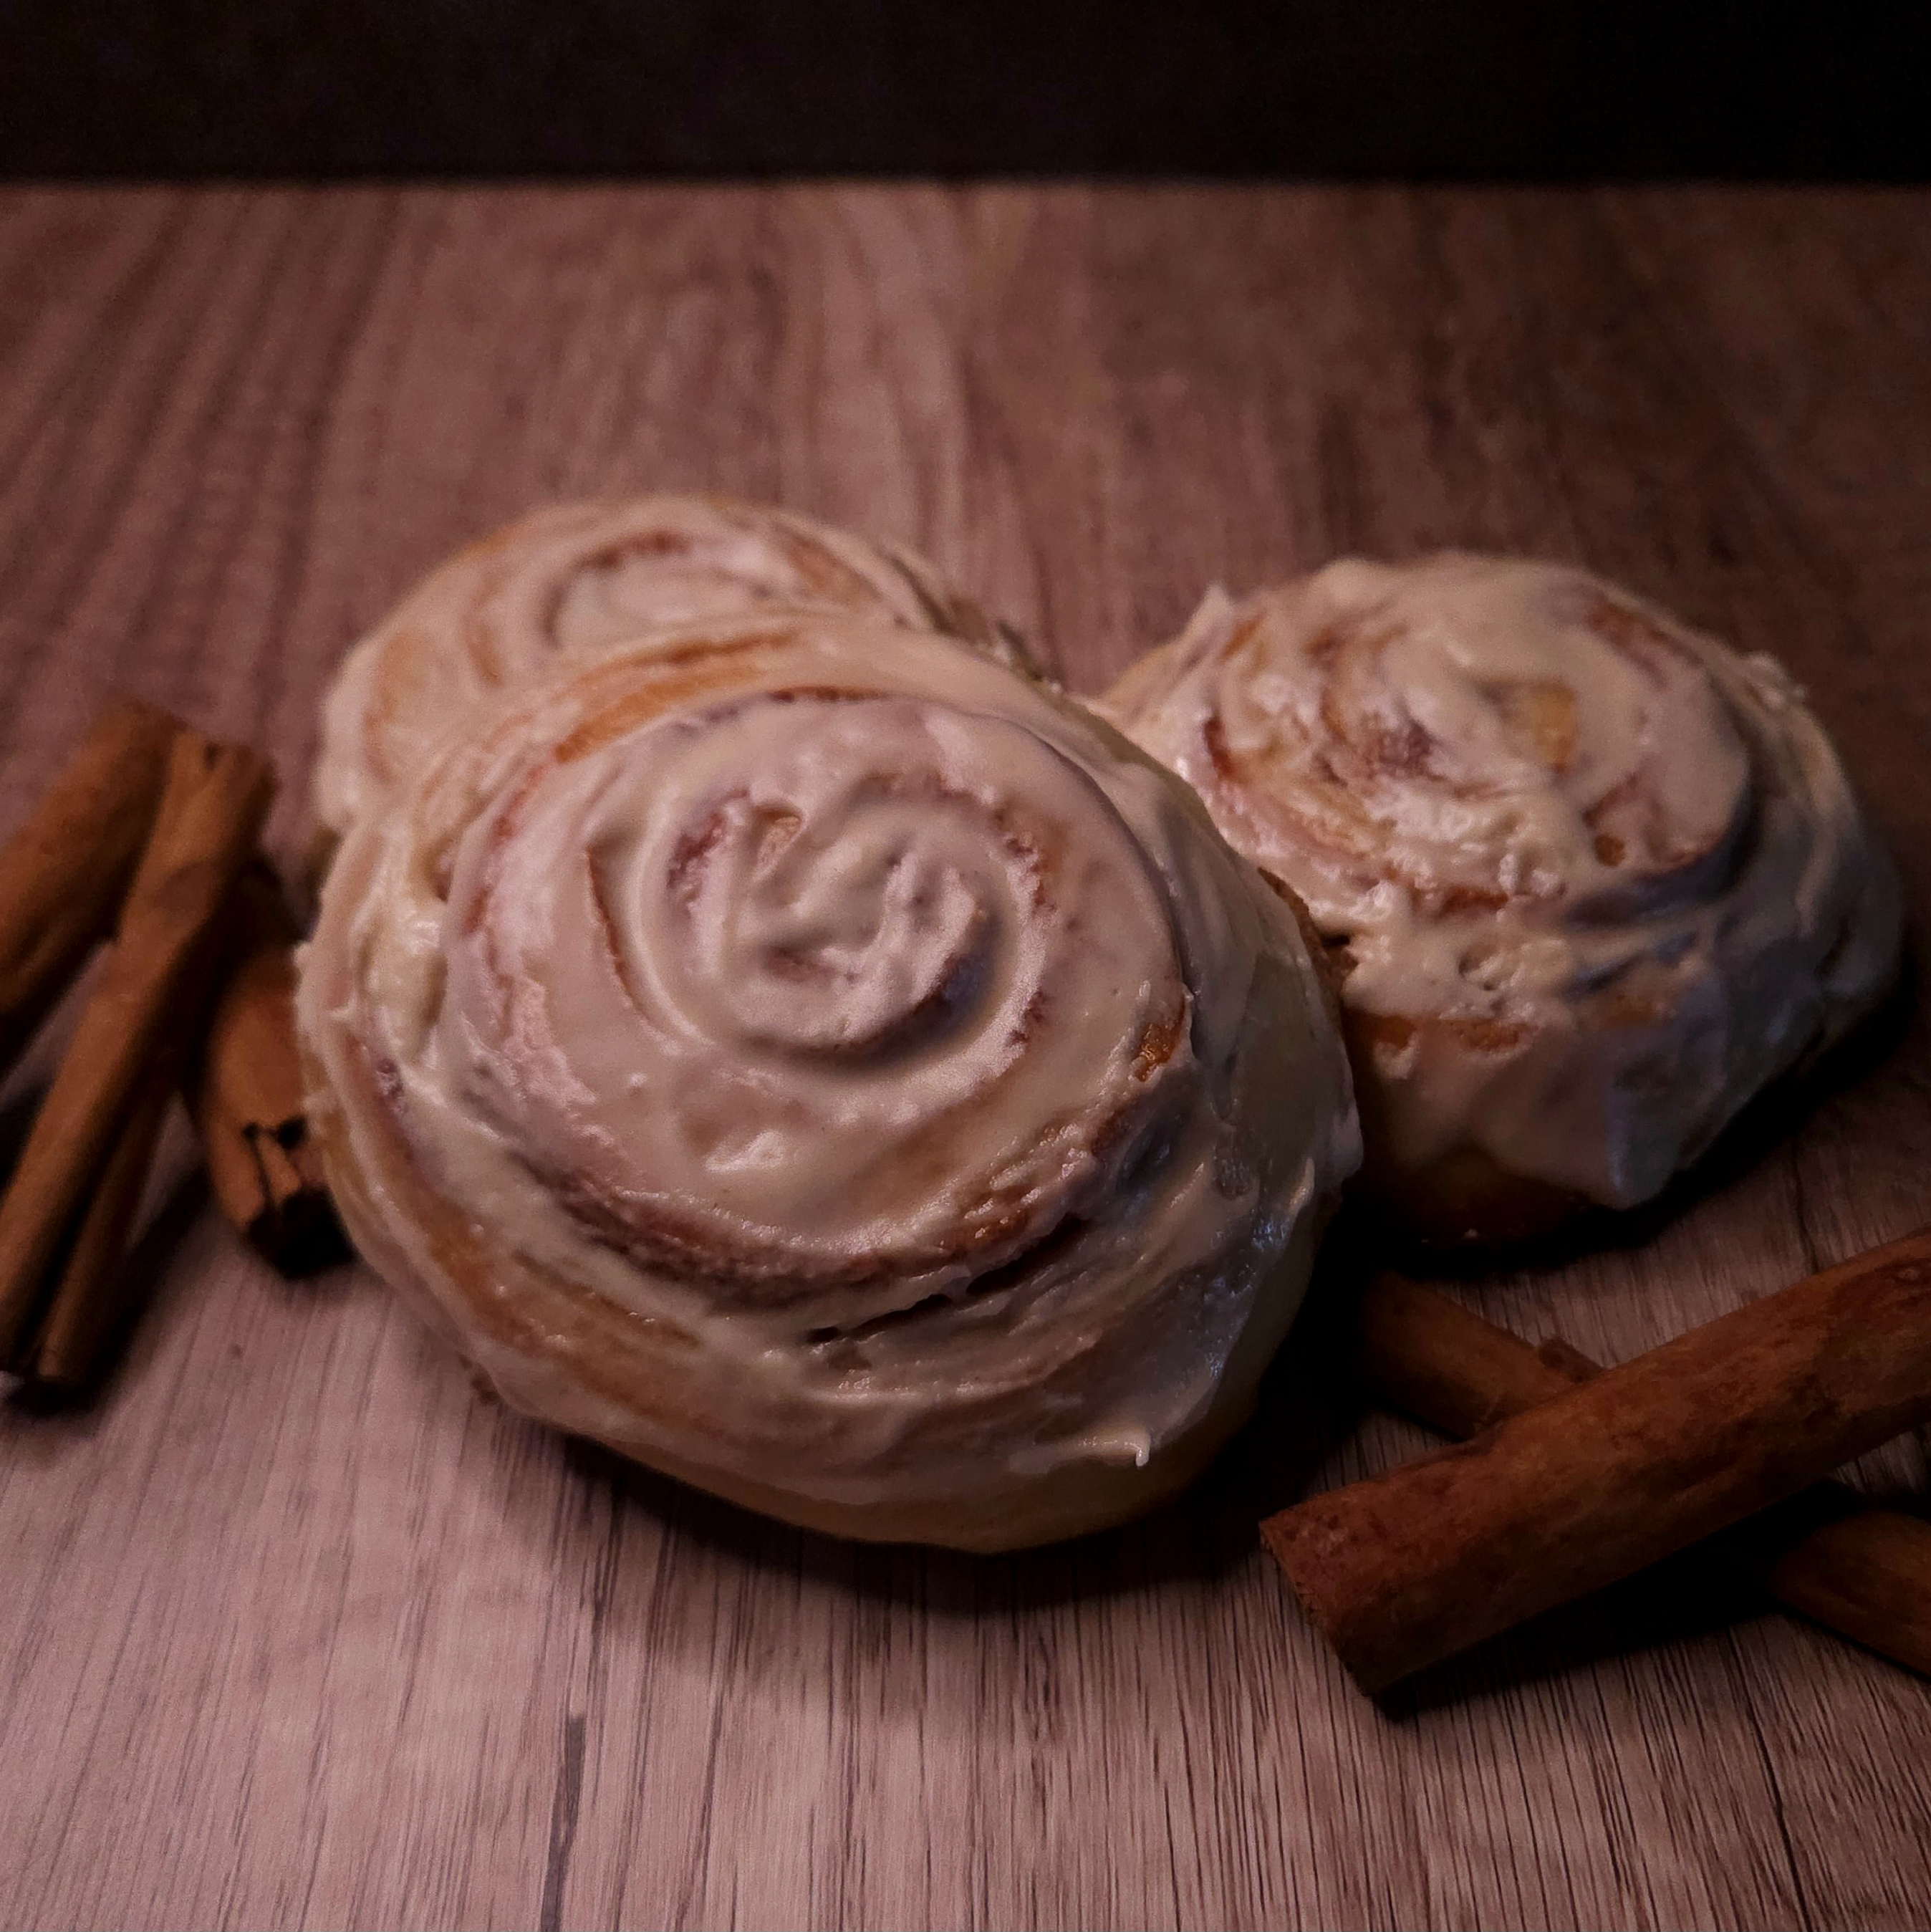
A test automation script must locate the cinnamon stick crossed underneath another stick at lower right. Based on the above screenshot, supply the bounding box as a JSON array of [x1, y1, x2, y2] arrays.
[[1356, 1275, 1931, 1677]]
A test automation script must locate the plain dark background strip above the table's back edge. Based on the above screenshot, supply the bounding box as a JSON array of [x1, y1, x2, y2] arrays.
[[0, 0, 1931, 180]]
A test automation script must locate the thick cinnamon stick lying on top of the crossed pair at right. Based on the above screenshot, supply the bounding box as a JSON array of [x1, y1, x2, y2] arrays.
[[1261, 1229, 1931, 1691]]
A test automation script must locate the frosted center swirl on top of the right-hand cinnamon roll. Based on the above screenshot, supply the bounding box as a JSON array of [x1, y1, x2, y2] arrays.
[[1207, 566, 1753, 918]]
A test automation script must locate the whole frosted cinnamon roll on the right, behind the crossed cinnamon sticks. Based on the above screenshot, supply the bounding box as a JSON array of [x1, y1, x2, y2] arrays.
[[1107, 554, 1898, 1240]]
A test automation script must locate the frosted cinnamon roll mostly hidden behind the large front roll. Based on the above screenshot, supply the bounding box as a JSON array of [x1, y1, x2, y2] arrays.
[[314, 496, 1033, 846]]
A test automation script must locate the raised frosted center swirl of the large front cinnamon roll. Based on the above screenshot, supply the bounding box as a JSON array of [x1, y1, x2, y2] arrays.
[[436, 690, 1191, 1325]]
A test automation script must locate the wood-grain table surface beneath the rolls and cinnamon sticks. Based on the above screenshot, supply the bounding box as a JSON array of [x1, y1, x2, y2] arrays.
[[0, 188, 1931, 1926]]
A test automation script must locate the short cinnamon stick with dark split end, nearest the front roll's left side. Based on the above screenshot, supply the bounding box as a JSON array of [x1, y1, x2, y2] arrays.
[[188, 862, 347, 1275]]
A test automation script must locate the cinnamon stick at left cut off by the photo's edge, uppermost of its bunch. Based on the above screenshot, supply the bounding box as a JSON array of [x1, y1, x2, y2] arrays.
[[0, 698, 180, 1076]]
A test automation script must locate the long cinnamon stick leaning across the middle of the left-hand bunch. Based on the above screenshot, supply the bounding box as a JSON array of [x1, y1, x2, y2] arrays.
[[0, 732, 274, 1362]]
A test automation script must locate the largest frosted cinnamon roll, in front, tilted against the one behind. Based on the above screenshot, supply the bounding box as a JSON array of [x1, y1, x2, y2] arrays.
[[299, 612, 1359, 1549]]
